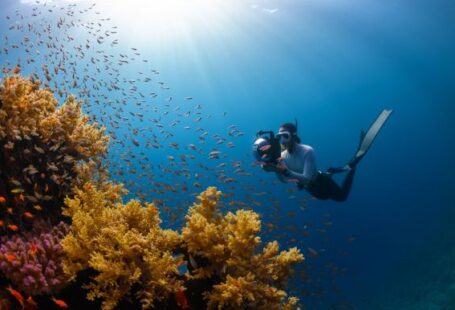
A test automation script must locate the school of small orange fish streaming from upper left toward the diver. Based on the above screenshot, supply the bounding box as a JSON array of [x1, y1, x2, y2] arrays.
[[0, 1, 354, 308]]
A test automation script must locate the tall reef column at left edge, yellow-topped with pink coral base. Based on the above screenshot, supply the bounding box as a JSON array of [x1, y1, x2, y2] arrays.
[[0, 72, 108, 307]]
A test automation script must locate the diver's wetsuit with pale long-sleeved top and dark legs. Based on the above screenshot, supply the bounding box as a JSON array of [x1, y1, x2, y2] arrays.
[[277, 144, 355, 201]]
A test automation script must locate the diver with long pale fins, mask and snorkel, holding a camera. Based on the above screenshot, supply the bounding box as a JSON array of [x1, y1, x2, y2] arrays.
[[253, 110, 392, 201]]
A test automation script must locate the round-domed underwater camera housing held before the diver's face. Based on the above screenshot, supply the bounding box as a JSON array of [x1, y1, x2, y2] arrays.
[[253, 130, 281, 164]]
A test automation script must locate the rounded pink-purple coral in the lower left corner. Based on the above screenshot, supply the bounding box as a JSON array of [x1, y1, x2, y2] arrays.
[[0, 222, 68, 295]]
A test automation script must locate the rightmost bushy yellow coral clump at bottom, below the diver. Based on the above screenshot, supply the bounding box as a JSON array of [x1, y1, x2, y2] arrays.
[[182, 187, 303, 309]]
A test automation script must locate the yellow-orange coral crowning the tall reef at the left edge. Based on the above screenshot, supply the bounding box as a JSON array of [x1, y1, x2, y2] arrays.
[[0, 75, 109, 158]]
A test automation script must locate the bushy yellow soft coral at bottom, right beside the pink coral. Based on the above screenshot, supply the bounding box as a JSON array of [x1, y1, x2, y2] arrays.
[[62, 183, 182, 309]]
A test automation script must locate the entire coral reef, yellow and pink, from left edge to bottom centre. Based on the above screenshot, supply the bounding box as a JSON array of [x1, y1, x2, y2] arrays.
[[0, 69, 303, 309]]
